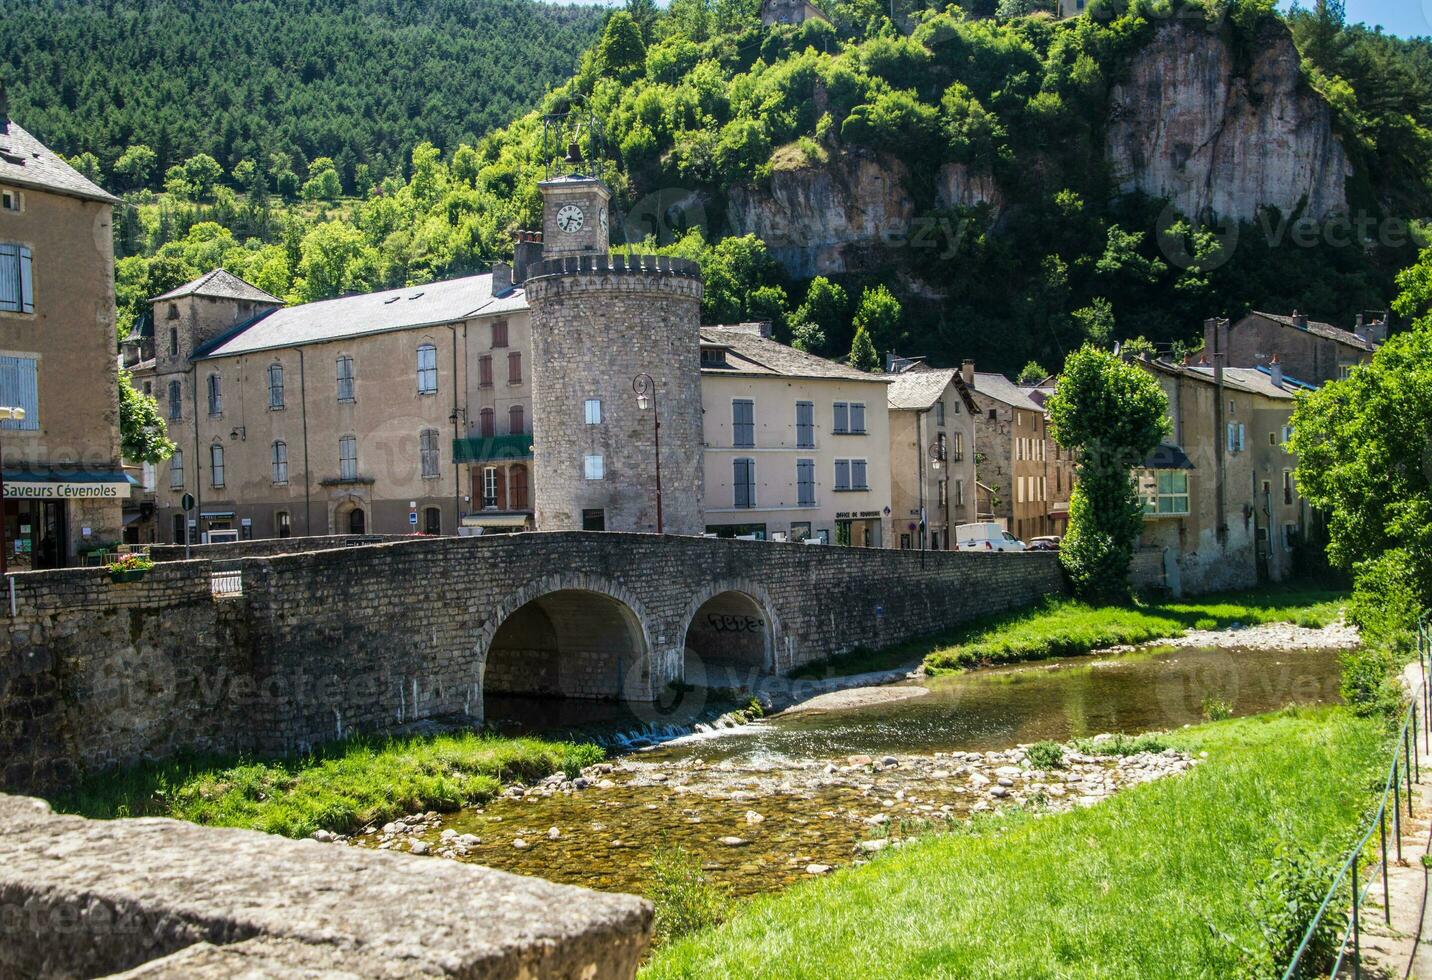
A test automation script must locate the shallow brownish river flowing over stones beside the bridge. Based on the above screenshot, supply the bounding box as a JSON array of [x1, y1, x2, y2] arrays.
[[361, 648, 1337, 894]]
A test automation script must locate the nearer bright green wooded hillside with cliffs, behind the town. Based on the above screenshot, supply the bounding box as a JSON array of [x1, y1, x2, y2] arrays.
[[13, 0, 1432, 371]]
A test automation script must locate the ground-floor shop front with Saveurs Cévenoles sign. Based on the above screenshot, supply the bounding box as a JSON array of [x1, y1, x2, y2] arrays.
[[3, 470, 132, 572]]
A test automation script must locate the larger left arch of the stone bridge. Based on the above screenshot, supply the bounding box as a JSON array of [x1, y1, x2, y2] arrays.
[[478, 573, 653, 716]]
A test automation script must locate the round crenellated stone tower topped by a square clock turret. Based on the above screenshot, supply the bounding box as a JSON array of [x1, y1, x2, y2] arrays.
[[523, 175, 705, 534]]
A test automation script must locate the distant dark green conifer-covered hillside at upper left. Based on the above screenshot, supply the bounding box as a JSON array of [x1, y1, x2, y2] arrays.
[[0, 0, 601, 189]]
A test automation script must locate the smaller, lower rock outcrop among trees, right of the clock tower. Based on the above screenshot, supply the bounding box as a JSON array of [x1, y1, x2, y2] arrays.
[[727, 149, 915, 278]]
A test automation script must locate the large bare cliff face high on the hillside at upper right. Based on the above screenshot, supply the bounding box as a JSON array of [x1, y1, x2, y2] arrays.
[[1106, 21, 1352, 219]]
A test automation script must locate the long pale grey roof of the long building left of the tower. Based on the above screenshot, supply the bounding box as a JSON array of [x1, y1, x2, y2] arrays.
[[196, 272, 527, 357]]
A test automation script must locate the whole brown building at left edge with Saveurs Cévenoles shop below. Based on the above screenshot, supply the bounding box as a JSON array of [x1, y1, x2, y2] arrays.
[[0, 87, 130, 570]]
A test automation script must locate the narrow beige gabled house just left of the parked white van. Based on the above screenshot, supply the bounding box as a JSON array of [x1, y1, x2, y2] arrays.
[[888, 367, 979, 552]]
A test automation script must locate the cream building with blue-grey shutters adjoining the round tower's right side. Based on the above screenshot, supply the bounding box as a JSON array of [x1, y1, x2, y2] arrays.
[[700, 324, 891, 547]]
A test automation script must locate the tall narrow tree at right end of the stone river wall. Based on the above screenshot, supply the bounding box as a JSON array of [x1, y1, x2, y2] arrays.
[[1047, 344, 1170, 602]]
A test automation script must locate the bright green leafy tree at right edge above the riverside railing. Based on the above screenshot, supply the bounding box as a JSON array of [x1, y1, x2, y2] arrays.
[[1289, 248, 1432, 638]]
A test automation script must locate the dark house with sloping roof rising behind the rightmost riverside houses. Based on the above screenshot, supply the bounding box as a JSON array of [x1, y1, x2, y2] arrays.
[[1203, 311, 1388, 384]]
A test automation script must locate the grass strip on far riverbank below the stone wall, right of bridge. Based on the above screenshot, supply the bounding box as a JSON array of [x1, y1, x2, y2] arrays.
[[924, 589, 1345, 672]]
